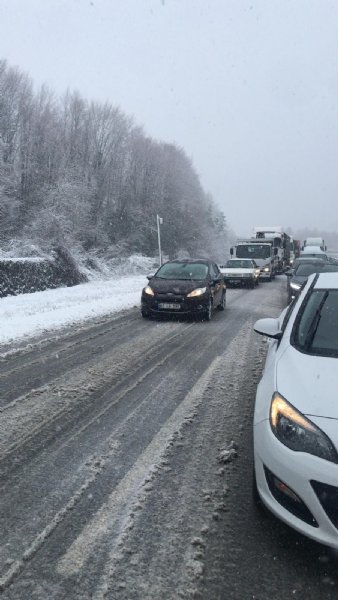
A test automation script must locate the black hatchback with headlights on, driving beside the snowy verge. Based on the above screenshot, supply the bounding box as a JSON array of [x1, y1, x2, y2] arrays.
[[141, 259, 226, 321]]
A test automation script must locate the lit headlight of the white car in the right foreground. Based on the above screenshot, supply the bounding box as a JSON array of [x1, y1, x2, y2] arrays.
[[270, 392, 338, 463]]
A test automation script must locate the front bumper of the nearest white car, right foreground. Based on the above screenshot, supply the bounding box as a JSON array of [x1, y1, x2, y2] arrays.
[[254, 420, 338, 549]]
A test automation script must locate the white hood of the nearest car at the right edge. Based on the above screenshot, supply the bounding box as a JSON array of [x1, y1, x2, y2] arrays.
[[276, 346, 338, 419]]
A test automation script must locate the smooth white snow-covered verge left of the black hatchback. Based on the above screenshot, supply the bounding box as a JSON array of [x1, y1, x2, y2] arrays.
[[0, 275, 147, 344]]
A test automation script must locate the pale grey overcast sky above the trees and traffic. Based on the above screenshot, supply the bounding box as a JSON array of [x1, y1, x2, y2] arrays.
[[0, 0, 338, 235]]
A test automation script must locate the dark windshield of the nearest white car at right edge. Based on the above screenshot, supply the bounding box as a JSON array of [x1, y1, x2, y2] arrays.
[[294, 290, 338, 357]]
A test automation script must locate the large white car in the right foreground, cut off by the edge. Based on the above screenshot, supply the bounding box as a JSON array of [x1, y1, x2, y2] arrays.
[[254, 273, 338, 549]]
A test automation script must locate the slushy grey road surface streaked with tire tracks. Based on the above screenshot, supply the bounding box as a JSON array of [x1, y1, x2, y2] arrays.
[[0, 277, 338, 600]]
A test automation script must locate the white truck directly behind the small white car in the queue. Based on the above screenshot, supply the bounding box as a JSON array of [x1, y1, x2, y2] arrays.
[[230, 238, 277, 281]]
